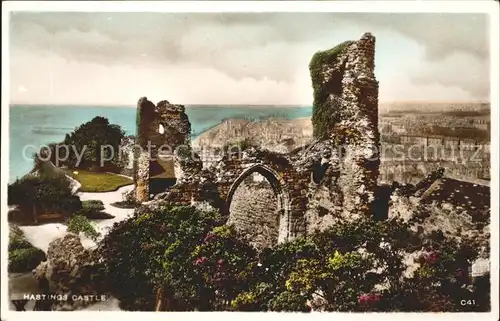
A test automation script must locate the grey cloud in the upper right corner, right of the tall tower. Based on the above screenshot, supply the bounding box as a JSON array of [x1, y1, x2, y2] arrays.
[[340, 13, 490, 100]]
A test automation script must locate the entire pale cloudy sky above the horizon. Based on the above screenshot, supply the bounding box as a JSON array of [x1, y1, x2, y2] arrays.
[[10, 12, 490, 106]]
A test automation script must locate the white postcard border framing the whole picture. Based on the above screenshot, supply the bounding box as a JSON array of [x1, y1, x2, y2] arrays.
[[1, 1, 500, 321]]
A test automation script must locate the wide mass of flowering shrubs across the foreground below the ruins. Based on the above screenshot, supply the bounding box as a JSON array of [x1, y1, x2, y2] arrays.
[[96, 202, 486, 312]]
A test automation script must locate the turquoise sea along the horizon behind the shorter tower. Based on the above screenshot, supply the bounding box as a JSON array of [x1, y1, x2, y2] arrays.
[[9, 105, 312, 183]]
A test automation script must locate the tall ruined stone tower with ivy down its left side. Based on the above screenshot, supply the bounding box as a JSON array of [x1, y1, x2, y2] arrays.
[[309, 33, 380, 218]]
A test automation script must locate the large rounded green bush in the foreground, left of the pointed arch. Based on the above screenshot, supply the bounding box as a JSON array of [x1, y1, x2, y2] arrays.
[[99, 206, 224, 311]]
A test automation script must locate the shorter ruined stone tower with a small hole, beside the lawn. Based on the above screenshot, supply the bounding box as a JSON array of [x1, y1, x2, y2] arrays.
[[134, 97, 191, 202]]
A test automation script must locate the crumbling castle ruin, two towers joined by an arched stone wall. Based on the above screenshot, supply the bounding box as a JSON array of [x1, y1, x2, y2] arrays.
[[134, 33, 379, 242]]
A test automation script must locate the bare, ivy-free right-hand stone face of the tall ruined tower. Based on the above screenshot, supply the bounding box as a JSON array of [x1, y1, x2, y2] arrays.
[[335, 34, 380, 215]]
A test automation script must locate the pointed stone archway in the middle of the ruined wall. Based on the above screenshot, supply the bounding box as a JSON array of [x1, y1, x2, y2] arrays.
[[226, 164, 289, 246]]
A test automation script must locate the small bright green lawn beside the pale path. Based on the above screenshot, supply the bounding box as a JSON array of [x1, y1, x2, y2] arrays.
[[64, 169, 133, 192]]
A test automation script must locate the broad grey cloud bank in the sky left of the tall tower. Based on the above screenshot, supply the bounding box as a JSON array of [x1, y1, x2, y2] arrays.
[[11, 13, 352, 82]]
